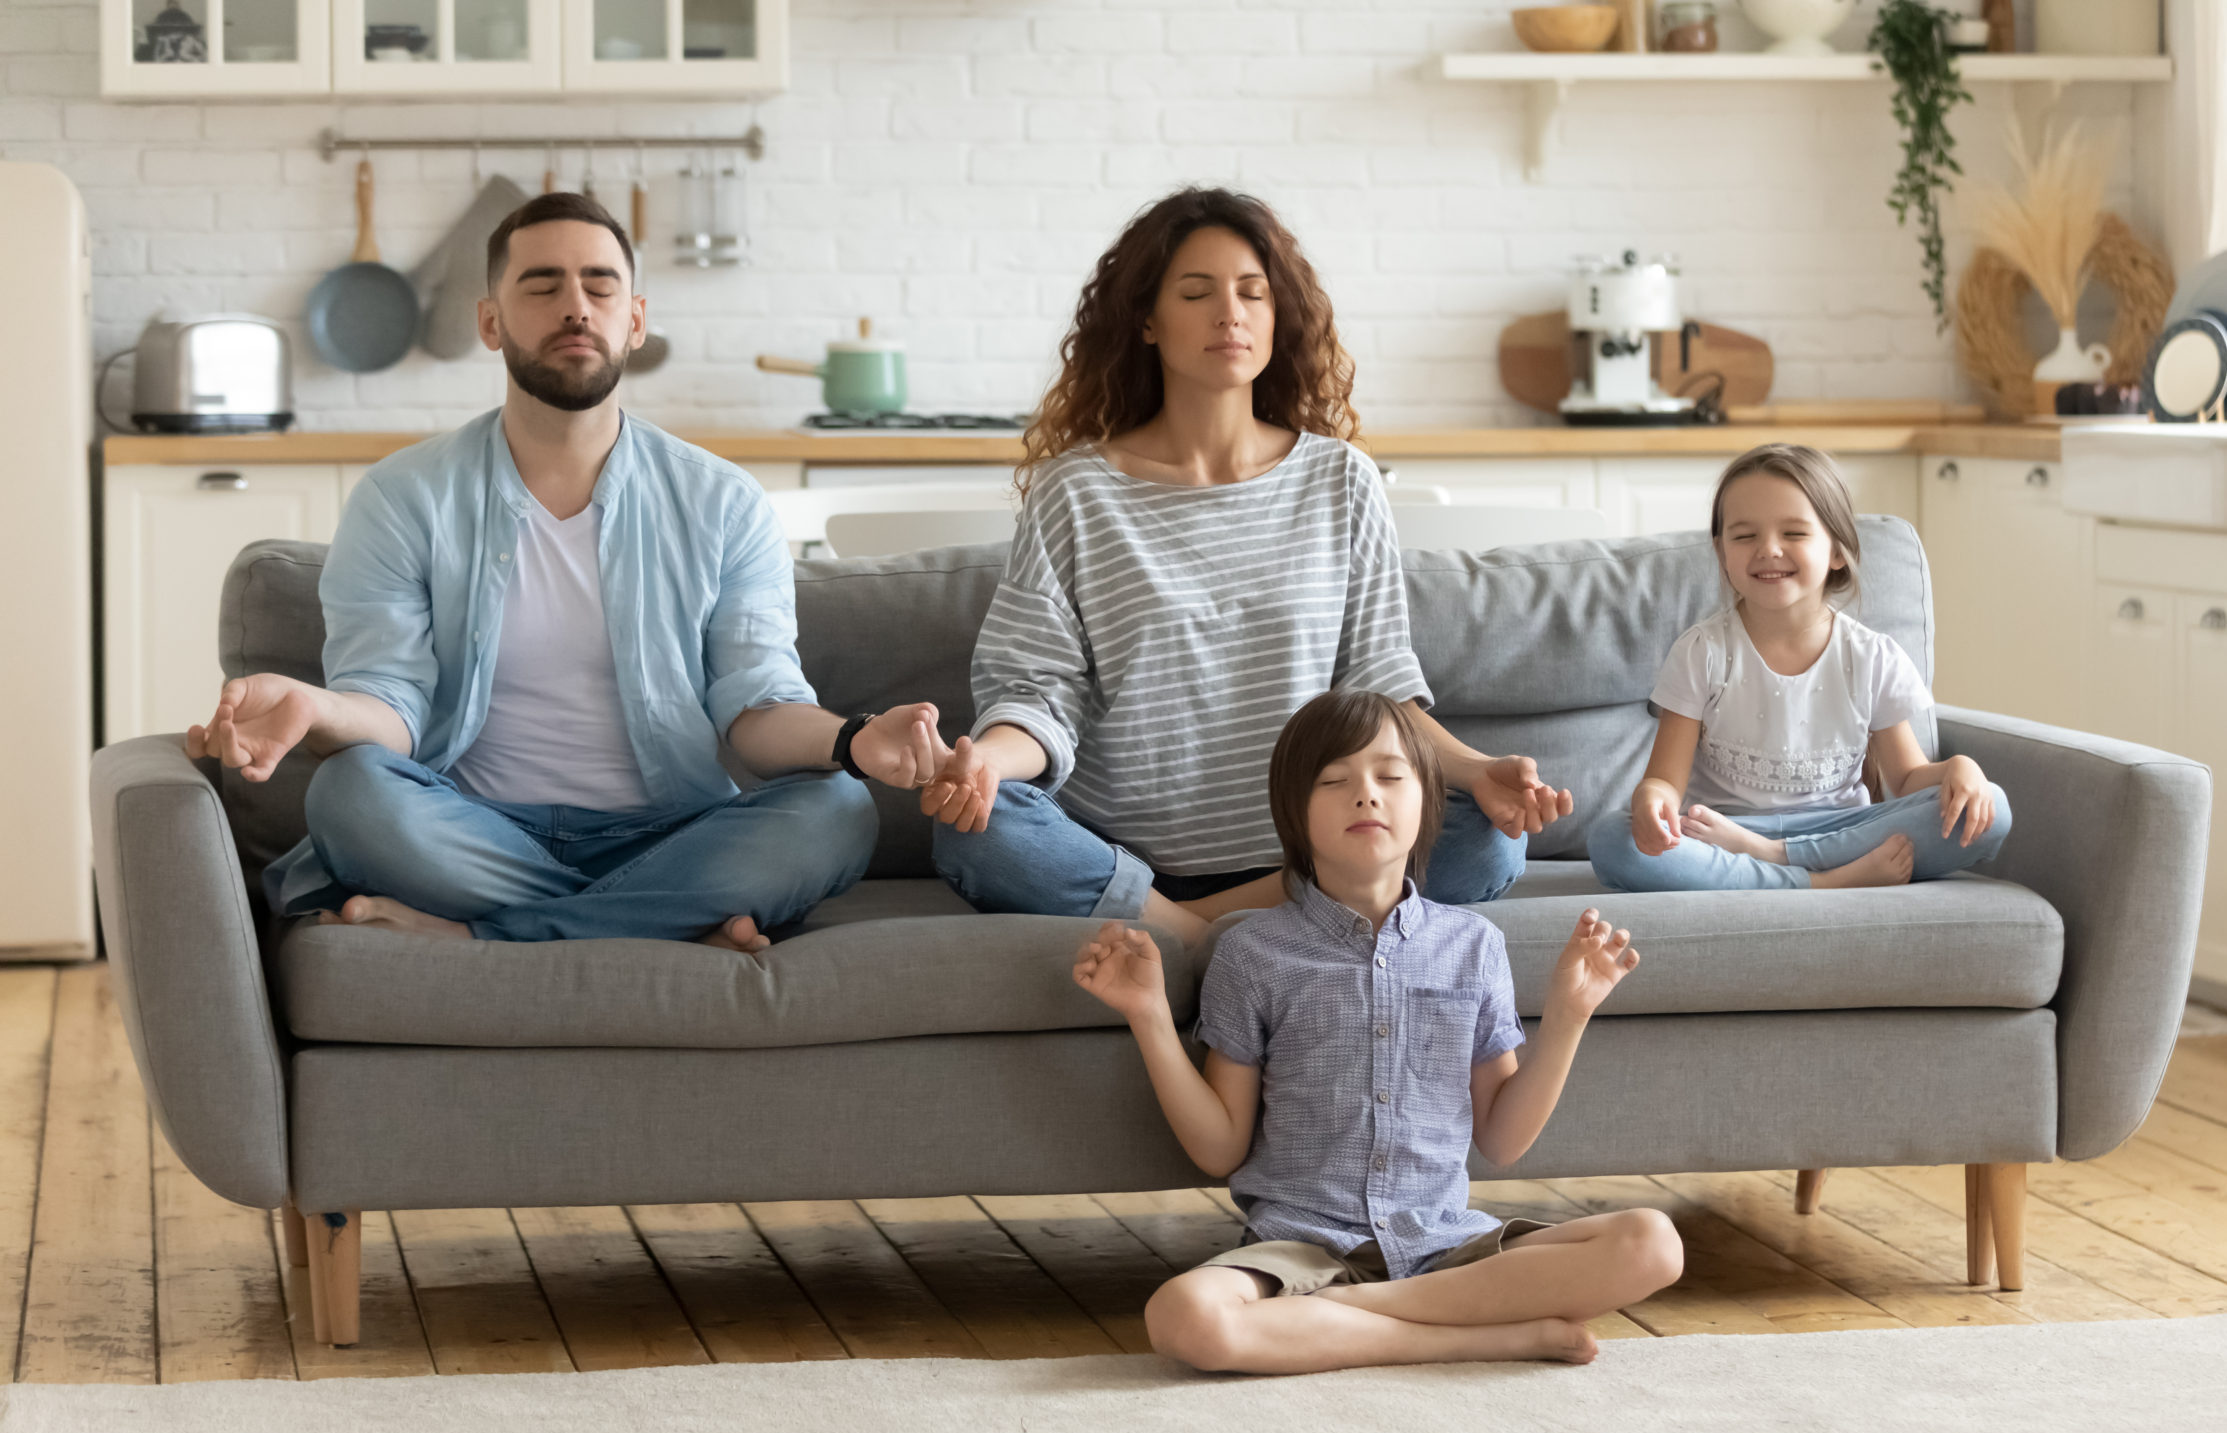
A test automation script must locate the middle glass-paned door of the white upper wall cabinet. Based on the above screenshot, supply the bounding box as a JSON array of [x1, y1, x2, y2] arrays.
[[332, 0, 563, 96]]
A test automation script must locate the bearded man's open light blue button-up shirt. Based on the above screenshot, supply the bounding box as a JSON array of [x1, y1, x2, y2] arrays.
[[265, 408, 815, 909]]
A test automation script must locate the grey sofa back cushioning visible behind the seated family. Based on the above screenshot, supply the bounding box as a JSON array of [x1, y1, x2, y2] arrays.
[[218, 517, 1933, 878]]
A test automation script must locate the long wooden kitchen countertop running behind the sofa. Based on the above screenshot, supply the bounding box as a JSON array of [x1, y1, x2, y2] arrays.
[[102, 423, 2060, 464]]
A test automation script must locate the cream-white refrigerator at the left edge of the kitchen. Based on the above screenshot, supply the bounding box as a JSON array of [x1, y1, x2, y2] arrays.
[[0, 163, 94, 961]]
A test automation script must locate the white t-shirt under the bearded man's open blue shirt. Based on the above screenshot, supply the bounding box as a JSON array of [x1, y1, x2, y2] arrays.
[[448, 504, 650, 811]]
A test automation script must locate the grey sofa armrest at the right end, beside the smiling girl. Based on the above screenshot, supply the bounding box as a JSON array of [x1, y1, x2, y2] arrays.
[[1937, 706, 2211, 1159]]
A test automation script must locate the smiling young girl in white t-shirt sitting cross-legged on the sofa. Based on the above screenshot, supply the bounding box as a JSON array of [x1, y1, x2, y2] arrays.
[[1588, 443, 2011, 891]]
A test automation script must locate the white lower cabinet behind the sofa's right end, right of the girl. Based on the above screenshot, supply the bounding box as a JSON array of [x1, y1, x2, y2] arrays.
[[1920, 457, 2093, 727]]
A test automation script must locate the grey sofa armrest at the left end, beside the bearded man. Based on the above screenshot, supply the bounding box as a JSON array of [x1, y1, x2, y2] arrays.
[[94, 735, 287, 1208]]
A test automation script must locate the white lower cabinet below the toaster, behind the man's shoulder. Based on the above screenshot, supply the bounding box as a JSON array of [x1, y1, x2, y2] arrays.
[[100, 464, 341, 742]]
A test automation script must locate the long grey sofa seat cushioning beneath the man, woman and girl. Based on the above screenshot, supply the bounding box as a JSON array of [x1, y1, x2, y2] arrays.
[[276, 860, 2064, 1050]]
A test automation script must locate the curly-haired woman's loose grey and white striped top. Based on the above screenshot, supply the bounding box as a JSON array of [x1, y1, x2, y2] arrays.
[[973, 432, 1430, 876]]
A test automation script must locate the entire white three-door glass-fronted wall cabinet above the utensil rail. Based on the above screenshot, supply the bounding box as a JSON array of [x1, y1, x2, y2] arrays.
[[100, 0, 788, 98]]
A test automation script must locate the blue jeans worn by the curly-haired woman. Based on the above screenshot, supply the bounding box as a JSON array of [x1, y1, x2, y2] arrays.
[[935, 782, 1528, 920]]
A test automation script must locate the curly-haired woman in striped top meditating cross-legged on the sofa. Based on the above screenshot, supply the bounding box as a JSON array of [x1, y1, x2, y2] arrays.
[[922, 189, 1570, 943]]
